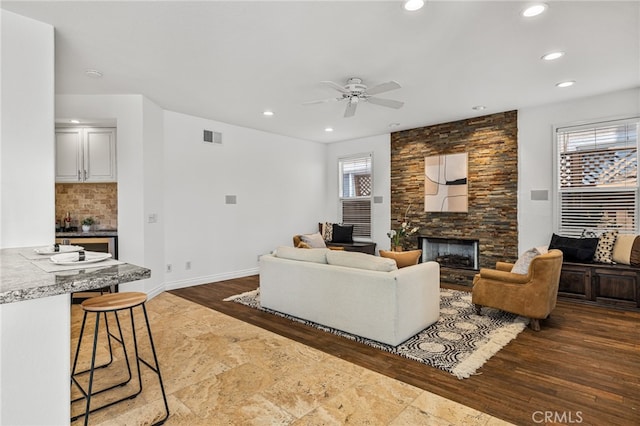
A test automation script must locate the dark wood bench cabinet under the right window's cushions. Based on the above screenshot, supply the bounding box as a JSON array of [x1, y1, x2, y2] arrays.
[[558, 262, 640, 309]]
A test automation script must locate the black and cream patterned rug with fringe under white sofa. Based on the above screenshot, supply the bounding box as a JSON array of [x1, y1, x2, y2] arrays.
[[224, 289, 528, 379]]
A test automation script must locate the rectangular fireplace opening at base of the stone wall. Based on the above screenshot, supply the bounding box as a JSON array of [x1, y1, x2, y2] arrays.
[[418, 235, 479, 270]]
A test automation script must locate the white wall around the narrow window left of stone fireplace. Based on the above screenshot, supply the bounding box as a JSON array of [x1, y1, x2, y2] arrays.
[[320, 134, 391, 253]]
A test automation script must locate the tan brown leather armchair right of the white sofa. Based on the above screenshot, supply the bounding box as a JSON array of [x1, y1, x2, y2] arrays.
[[471, 250, 562, 331]]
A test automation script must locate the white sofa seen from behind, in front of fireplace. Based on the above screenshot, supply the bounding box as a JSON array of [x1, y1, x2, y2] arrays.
[[260, 247, 440, 346]]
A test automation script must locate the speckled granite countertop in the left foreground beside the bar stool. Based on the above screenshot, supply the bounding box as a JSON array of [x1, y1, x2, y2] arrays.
[[0, 247, 151, 303]]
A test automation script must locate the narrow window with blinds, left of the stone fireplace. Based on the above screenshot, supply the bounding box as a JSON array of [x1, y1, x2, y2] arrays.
[[338, 154, 373, 238]]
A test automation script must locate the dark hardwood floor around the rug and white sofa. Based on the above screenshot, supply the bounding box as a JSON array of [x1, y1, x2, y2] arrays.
[[170, 276, 640, 426]]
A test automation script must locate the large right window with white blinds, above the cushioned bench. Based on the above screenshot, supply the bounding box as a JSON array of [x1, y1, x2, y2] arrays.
[[556, 118, 640, 236]]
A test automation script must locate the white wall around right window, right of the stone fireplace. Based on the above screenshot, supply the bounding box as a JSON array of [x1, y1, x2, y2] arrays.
[[518, 88, 640, 253]]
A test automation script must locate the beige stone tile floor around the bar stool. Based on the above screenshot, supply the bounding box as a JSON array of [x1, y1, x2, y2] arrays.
[[71, 293, 509, 426]]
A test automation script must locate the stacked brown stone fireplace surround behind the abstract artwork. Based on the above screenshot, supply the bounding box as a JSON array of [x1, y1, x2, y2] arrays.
[[390, 111, 518, 285]]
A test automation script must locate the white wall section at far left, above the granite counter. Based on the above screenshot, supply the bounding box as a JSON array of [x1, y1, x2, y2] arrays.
[[0, 11, 55, 247]]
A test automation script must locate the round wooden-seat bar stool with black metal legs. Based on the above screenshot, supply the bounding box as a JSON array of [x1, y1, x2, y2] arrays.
[[71, 292, 169, 425]]
